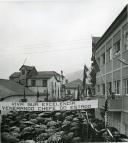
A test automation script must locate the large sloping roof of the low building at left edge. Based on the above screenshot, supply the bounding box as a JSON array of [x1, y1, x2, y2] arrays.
[[0, 79, 34, 98]]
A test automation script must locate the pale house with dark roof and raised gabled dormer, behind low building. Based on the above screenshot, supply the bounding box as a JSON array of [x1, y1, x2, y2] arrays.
[[10, 65, 65, 99]]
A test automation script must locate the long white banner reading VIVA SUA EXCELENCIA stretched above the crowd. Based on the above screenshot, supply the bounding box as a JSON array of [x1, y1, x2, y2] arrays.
[[0, 100, 98, 111]]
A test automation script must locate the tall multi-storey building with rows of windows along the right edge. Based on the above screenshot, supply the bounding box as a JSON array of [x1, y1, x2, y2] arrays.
[[93, 5, 128, 135]]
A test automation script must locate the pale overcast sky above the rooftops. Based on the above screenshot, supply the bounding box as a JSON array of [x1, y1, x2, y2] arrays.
[[0, 0, 128, 79]]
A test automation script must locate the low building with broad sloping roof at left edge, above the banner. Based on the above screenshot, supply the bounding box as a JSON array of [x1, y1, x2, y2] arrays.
[[0, 79, 36, 102]]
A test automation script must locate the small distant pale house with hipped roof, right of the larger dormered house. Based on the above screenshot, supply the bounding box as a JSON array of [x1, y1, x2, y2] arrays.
[[65, 79, 83, 100]]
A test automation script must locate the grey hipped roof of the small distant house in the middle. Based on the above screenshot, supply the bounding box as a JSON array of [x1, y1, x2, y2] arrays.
[[65, 79, 83, 89]]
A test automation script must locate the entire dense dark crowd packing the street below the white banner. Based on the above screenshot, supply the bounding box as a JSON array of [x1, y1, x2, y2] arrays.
[[1, 109, 128, 143]]
